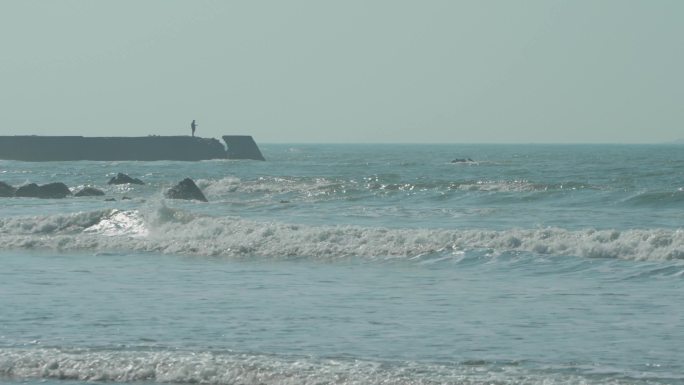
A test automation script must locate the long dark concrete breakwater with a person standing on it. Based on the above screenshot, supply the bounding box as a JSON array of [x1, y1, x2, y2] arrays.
[[0, 135, 264, 162]]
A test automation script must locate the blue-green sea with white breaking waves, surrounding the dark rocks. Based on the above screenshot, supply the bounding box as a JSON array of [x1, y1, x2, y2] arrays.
[[0, 144, 684, 385]]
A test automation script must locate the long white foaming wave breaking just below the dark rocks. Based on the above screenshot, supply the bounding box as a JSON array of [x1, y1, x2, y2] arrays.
[[0, 203, 684, 260]]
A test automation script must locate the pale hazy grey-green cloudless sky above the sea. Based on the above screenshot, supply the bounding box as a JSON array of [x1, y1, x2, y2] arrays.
[[0, 0, 684, 143]]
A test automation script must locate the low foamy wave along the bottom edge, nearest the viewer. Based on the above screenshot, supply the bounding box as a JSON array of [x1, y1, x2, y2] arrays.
[[0, 348, 668, 385]]
